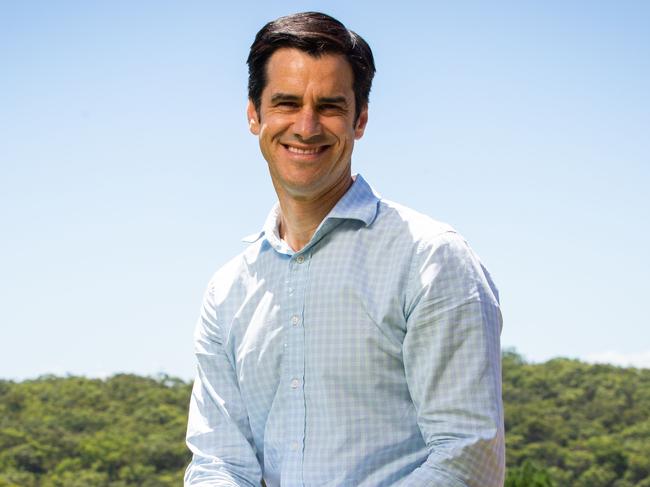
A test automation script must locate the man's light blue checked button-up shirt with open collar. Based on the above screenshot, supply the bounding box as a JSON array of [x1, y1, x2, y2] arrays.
[[185, 176, 504, 487]]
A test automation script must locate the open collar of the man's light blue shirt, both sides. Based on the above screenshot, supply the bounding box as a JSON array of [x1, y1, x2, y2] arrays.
[[243, 174, 381, 248]]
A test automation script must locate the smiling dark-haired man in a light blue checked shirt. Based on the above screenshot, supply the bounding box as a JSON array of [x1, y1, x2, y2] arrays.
[[185, 12, 504, 487]]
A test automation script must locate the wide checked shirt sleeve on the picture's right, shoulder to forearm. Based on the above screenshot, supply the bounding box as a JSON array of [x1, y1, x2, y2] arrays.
[[399, 232, 505, 487]]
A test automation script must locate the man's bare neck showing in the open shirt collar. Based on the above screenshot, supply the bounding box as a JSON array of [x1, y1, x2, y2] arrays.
[[277, 175, 353, 252]]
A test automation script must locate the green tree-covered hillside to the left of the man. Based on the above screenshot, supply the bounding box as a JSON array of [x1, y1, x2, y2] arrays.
[[0, 375, 191, 487]]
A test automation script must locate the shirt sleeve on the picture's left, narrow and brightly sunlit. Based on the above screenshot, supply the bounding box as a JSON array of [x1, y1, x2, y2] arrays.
[[184, 284, 262, 487]]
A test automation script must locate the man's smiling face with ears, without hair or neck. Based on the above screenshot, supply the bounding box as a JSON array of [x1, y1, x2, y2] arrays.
[[247, 48, 368, 199]]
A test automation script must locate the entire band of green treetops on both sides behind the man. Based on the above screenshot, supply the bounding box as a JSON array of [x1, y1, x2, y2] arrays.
[[0, 352, 650, 487]]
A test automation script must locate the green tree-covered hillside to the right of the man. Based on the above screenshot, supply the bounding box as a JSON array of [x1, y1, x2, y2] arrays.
[[503, 351, 650, 487]]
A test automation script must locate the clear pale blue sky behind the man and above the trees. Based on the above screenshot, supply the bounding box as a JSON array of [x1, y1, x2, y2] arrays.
[[0, 1, 650, 379]]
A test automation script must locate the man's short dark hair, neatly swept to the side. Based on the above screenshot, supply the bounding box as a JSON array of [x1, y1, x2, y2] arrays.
[[246, 12, 375, 120]]
